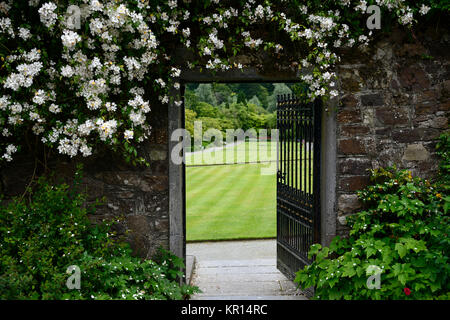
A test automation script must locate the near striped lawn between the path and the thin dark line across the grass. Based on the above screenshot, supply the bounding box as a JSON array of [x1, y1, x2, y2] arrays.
[[186, 164, 276, 241]]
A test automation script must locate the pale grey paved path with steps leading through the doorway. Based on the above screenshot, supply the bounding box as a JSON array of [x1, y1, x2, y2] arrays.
[[186, 239, 307, 300]]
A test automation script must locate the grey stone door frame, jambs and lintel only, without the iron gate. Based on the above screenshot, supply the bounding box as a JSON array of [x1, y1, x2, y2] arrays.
[[168, 69, 336, 288]]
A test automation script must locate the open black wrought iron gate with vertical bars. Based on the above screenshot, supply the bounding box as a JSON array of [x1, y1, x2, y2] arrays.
[[277, 95, 321, 279]]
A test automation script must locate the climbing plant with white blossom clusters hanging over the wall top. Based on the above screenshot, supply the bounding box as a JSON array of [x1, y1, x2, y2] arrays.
[[0, 0, 442, 163]]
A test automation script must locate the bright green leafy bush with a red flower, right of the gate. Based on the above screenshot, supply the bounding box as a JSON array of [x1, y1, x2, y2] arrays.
[[295, 168, 450, 299]]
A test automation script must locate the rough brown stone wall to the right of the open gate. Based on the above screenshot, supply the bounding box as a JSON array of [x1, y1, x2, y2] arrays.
[[336, 28, 450, 234]]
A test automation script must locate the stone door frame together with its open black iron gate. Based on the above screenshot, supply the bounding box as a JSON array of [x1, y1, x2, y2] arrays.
[[169, 70, 336, 298]]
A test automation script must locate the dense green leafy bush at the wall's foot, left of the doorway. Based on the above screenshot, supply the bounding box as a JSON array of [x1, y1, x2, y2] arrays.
[[0, 172, 197, 299]]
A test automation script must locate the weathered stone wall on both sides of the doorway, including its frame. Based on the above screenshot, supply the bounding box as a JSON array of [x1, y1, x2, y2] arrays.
[[0, 28, 450, 268]]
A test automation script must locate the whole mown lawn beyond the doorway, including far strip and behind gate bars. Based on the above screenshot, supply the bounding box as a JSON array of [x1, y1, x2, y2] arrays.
[[186, 142, 312, 241]]
